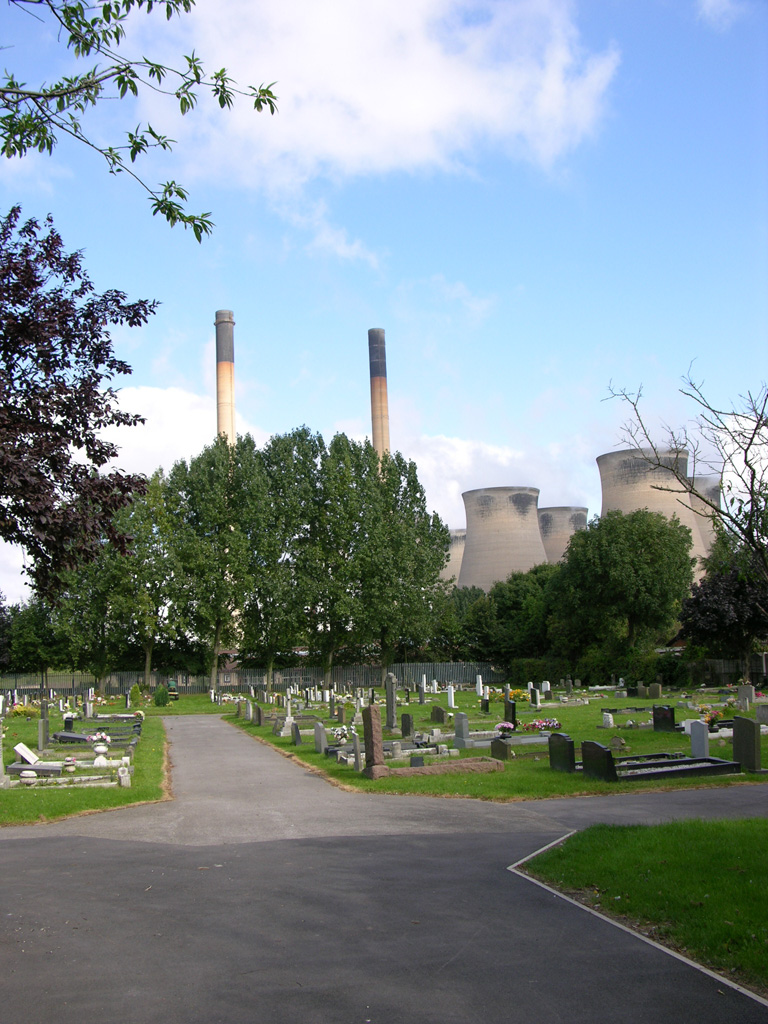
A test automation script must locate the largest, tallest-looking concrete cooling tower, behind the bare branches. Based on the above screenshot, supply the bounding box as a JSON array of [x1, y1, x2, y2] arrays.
[[597, 449, 707, 559]]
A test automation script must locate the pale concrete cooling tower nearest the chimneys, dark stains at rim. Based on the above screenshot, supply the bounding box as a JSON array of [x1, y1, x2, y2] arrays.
[[459, 487, 547, 591]]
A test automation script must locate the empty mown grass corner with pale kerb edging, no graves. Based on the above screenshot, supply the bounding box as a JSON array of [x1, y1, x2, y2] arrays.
[[525, 818, 768, 995]]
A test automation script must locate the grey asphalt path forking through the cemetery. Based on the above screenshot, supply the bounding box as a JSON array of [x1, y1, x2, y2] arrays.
[[0, 716, 768, 1024]]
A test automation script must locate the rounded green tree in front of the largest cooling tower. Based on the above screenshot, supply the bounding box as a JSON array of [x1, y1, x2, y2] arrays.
[[550, 509, 694, 653]]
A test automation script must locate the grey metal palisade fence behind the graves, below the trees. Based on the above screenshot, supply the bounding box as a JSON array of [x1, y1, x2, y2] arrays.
[[0, 662, 506, 697]]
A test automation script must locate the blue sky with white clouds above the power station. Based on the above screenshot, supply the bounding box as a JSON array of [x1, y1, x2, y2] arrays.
[[0, 0, 768, 600]]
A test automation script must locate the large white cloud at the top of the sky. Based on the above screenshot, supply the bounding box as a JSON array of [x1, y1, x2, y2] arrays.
[[137, 0, 618, 196]]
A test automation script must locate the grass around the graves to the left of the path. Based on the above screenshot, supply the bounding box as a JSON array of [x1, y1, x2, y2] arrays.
[[0, 713, 167, 826]]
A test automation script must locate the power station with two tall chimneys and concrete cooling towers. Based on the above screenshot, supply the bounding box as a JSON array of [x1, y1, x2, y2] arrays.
[[214, 309, 721, 592]]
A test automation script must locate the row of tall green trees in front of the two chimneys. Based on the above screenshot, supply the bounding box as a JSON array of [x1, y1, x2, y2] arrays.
[[1, 427, 450, 681]]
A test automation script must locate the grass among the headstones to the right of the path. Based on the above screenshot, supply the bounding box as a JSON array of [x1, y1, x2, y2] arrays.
[[230, 692, 768, 801]]
